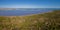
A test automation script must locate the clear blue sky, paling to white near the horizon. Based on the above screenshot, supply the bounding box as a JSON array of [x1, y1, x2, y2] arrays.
[[0, 0, 60, 8]]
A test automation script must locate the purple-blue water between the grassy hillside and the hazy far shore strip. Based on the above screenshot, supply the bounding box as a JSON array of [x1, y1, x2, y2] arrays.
[[0, 9, 60, 16]]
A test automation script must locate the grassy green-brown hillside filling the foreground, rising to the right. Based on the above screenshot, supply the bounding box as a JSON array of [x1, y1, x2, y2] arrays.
[[0, 10, 60, 30]]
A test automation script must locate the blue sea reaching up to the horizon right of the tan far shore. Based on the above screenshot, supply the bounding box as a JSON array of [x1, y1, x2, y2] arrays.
[[0, 8, 60, 16]]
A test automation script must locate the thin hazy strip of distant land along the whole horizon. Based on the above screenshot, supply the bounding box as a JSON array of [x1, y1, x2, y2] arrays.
[[0, 8, 60, 10]]
